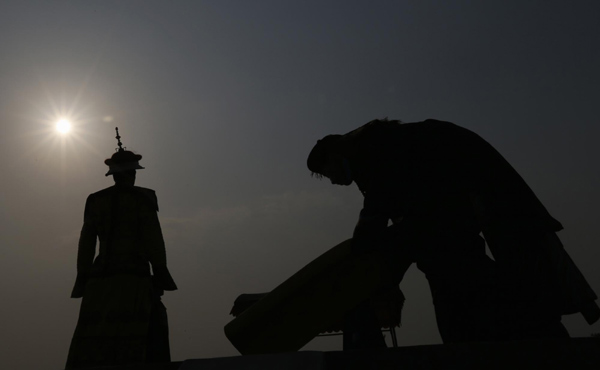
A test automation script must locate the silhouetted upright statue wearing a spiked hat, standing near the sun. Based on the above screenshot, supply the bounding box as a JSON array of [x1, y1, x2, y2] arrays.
[[66, 130, 177, 369]]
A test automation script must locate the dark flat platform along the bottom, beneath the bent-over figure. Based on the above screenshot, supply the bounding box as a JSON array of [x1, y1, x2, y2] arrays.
[[75, 338, 600, 370]]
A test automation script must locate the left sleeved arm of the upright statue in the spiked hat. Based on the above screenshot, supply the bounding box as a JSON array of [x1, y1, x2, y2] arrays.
[[71, 195, 98, 298]]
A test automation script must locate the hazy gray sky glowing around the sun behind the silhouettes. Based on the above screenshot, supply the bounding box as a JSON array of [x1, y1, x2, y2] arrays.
[[0, 0, 600, 369]]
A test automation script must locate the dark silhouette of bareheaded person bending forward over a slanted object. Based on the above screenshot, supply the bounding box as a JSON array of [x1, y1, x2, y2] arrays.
[[307, 119, 600, 349]]
